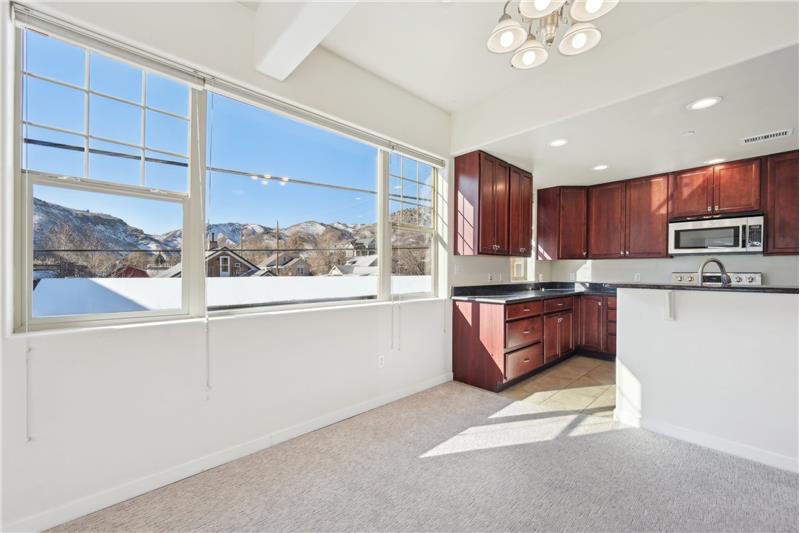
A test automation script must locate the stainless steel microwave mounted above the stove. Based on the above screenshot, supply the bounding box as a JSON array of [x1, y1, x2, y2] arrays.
[[669, 216, 764, 255]]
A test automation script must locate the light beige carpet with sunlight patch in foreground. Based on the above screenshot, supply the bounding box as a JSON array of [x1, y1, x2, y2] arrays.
[[56, 383, 798, 531]]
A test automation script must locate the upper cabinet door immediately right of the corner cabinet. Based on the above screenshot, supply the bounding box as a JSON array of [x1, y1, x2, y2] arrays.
[[589, 182, 625, 259]]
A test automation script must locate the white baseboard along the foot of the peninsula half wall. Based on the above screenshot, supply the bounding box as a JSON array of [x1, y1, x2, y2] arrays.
[[640, 418, 798, 473]]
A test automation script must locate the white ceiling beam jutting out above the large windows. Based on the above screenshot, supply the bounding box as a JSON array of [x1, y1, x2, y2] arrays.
[[253, 1, 356, 81]]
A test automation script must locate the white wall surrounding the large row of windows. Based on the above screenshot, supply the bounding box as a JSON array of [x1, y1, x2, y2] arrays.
[[0, 2, 452, 530]]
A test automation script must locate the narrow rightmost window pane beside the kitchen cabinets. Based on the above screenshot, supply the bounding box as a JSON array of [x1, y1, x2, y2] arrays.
[[389, 154, 436, 295]]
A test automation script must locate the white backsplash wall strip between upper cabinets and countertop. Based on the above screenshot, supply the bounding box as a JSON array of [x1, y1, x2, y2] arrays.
[[537, 254, 798, 287]]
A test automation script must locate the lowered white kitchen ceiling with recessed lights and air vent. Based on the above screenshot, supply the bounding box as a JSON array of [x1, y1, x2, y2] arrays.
[[485, 46, 798, 188]]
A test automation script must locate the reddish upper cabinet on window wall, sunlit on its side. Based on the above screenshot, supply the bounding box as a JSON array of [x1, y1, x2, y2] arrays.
[[455, 152, 533, 256]]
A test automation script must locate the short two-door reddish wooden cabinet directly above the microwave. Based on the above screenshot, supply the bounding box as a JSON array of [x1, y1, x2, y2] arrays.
[[669, 159, 761, 218]]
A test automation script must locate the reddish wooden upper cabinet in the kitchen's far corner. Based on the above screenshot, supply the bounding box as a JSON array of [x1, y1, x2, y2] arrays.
[[536, 187, 588, 260]]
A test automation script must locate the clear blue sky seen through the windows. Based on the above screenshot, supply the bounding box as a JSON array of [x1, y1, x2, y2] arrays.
[[23, 32, 431, 234]]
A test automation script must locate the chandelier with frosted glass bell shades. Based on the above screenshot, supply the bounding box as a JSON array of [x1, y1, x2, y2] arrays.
[[486, 0, 619, 69]]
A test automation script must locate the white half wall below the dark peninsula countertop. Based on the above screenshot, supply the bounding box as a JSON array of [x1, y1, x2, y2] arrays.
[[615, 289, 798, 472]]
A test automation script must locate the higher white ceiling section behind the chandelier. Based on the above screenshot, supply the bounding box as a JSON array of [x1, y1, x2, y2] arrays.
[[322, 1, 697, 112]]
